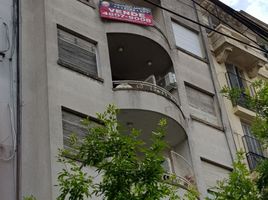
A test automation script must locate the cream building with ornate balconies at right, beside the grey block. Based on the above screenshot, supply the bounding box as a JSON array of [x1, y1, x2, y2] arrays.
[[202, 0, 268, 170]]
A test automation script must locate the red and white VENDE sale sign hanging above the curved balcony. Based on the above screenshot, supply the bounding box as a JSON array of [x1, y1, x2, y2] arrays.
[[100, 1, 153, 26]]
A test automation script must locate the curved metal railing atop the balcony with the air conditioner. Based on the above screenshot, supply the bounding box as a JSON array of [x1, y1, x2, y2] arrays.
[[113, 80, 179, 107]]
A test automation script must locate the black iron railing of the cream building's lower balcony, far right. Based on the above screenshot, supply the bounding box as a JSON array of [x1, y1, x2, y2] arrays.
[[242, 135, 265, 170]]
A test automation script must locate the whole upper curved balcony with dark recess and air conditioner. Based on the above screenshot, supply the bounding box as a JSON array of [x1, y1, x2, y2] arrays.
[[107, 33, 184, 122]]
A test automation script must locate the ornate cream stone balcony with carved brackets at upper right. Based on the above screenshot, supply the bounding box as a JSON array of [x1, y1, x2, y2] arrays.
[[209, 24, 267, 78]]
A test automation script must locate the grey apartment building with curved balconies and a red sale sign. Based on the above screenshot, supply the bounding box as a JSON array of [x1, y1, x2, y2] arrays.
[[0, 0, 264, 200]]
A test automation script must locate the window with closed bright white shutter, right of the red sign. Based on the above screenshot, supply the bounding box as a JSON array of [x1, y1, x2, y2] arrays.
[[172, 22, 204, 58]]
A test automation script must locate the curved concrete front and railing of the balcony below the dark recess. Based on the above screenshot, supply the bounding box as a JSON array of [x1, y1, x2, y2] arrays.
[[113, 80, 185, 127]]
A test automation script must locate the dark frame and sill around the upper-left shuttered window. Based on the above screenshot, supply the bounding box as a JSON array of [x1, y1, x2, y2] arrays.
[[57, 24, 104, 83]]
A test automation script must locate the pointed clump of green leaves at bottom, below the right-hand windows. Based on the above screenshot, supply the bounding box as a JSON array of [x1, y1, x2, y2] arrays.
[[207, 152, 260, 200]]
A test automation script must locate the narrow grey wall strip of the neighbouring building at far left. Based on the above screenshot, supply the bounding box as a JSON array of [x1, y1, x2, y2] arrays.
[[0, 0, 18, 200]]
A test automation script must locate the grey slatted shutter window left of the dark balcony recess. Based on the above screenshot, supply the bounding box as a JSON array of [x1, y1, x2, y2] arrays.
[[58, 27, 98, 78]]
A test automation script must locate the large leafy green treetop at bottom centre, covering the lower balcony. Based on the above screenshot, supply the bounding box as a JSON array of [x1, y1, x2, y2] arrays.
[[57, 105, 198, 200]]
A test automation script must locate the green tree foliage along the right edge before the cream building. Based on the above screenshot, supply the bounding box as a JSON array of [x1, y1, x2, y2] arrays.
[[222, 80, 268, 200]]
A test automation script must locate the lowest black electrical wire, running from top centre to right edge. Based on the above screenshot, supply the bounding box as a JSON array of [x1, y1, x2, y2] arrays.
[[144, 0, 268, 53]]
